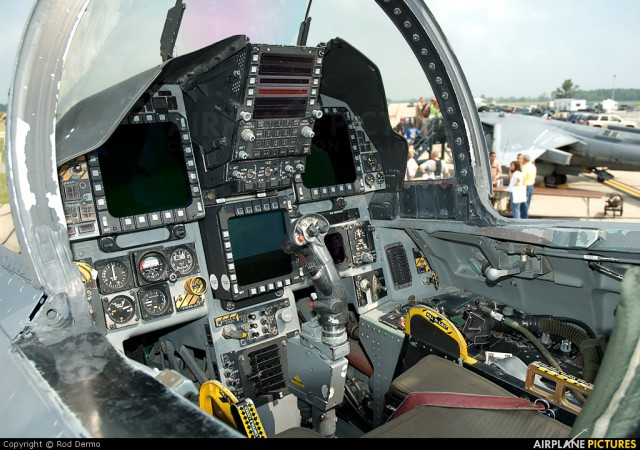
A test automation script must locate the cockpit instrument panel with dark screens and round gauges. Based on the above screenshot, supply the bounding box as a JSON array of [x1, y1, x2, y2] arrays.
[[59, 43, 396, 363]]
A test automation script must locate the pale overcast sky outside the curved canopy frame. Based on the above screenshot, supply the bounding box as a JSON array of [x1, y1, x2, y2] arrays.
[[0, 0, 640, 103]]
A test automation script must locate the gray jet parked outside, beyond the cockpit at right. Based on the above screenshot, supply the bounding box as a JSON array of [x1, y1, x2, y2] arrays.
[[479, 112, 640, 186]]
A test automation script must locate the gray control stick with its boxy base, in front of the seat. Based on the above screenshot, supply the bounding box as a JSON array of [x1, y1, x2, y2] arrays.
[[283, 213, 349, 437]]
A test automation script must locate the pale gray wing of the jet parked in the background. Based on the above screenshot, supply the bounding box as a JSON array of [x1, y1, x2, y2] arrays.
[[480, 112, 582, 165]]
